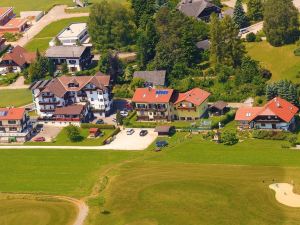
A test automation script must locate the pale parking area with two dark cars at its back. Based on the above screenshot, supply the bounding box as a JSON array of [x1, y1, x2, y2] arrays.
[[102, 128, 158, 150]]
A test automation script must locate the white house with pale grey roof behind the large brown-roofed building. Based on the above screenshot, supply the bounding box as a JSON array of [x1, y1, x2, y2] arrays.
[[45, 46, 93, 72]]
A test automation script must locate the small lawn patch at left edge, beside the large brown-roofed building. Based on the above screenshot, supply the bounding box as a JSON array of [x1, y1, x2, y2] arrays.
[[0, 89, 32, 107]]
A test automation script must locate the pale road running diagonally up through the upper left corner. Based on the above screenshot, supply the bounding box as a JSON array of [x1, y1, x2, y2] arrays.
[[7, 5, 89, 46]]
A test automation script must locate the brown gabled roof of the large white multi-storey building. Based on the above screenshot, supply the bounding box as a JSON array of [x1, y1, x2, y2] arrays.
[[33, 76, 109, 98]]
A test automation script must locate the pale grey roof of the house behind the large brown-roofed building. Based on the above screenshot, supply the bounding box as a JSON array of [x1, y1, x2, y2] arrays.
[[45, 46, 87, 58]]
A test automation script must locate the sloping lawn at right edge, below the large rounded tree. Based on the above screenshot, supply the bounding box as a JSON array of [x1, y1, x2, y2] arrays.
[[246, 41, 300, 81]]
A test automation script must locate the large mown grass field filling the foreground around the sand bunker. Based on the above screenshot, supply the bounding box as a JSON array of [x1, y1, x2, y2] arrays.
[[0, 133, 300, 225]]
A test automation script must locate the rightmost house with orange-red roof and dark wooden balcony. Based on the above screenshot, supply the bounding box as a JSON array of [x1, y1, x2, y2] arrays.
[[235, 97, 298, 130]]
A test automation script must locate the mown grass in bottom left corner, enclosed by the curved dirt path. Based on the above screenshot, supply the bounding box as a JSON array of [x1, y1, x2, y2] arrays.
[[0, 199, 77, 225]]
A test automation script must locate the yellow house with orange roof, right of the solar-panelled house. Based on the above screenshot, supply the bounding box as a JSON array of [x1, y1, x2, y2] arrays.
[[174, 88, 210, 120]]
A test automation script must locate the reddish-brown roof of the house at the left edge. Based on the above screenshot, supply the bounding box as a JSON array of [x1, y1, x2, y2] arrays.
[[2, 45, 36, 66]]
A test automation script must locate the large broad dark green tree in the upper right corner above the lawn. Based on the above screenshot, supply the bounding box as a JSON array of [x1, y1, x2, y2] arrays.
[[264, 0, 299, 46]]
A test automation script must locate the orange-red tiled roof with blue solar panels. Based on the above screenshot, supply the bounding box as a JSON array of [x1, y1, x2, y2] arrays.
[[132, 88, 173, 103]]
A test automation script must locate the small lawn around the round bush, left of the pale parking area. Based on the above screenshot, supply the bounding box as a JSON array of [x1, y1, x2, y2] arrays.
[[26, 128, 114, 146]]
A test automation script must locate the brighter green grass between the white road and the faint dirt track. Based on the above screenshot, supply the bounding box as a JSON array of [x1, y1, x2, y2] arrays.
[[0, 149, 136, 196]]
